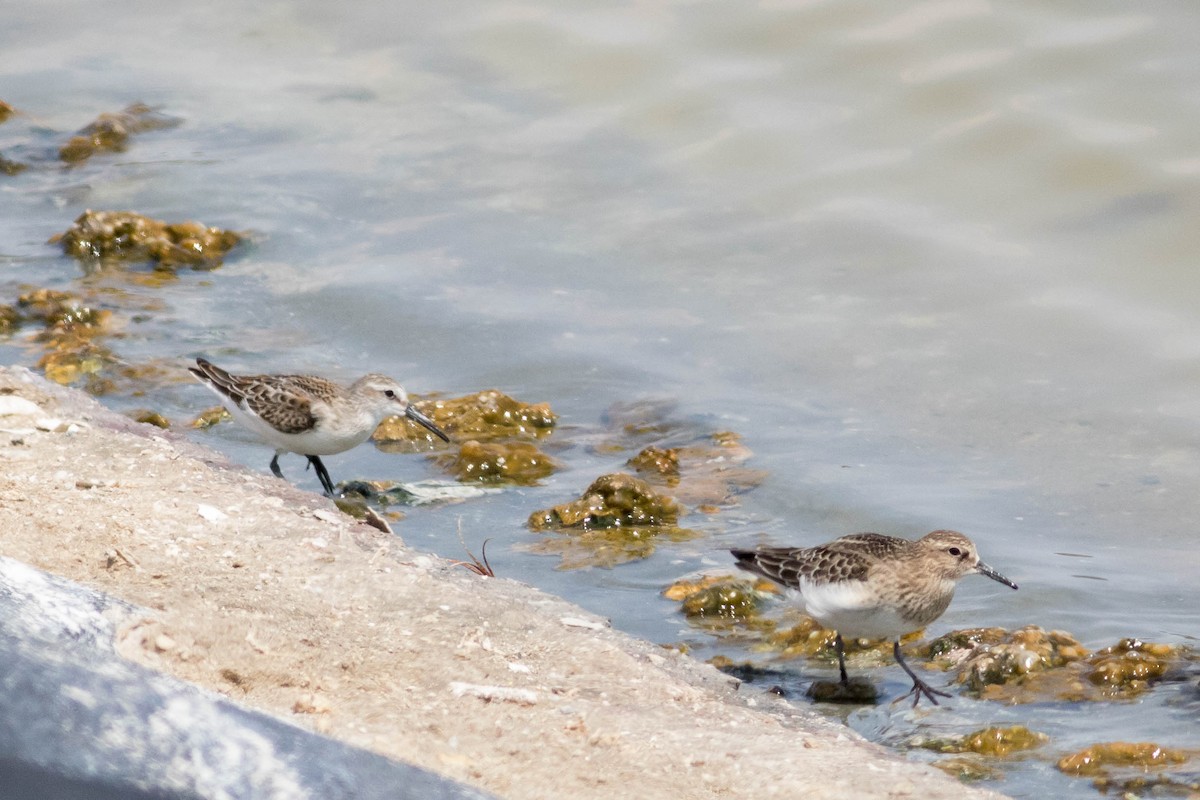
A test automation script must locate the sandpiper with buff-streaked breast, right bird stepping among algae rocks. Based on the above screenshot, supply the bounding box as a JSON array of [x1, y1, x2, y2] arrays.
[[730, 530, 1016, 708]]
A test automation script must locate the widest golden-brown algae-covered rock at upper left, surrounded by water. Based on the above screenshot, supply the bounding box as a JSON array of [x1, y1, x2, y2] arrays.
[[50, 210, 241, 271]]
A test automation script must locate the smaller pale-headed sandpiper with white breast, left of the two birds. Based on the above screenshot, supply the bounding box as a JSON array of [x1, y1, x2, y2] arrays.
[[188, 359, 450, 497]]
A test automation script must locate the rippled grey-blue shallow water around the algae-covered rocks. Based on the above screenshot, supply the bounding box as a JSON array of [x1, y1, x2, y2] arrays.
[[0, 0, 1200, 796]]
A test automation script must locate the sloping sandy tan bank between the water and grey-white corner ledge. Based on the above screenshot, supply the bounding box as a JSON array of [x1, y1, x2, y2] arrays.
[[0, 368, 1000, 800]]
